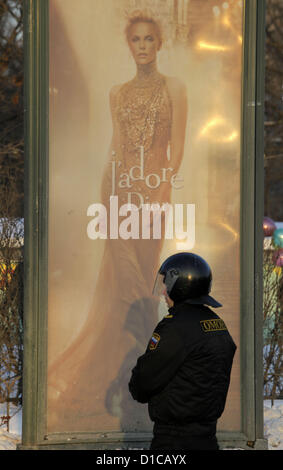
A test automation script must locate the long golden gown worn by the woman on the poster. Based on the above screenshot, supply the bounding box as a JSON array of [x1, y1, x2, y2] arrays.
[[48, 64, 175, 432]]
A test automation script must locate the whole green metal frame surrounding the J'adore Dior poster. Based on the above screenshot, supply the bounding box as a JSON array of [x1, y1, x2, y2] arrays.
[[19, 0, 267, 449]]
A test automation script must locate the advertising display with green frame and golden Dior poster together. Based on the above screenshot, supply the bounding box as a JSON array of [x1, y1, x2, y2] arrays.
[[23, 0, 264, 449]]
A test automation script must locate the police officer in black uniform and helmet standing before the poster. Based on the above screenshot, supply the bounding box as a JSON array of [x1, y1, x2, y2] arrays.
[[129, 253, 236, 450]]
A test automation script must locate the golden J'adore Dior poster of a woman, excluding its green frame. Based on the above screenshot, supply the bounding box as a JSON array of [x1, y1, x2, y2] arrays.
[[47, 0, 242, 432]]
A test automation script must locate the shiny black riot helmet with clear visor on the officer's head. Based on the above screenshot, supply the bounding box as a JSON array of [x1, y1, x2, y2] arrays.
[[153, 253, 222, 308]]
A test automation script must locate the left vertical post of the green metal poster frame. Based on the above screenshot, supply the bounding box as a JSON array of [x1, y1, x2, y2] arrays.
[[22, 0, 49, 445]]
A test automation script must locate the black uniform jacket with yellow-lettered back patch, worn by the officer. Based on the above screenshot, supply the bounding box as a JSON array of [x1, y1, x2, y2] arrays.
[[129, 302, 236, 429]]
